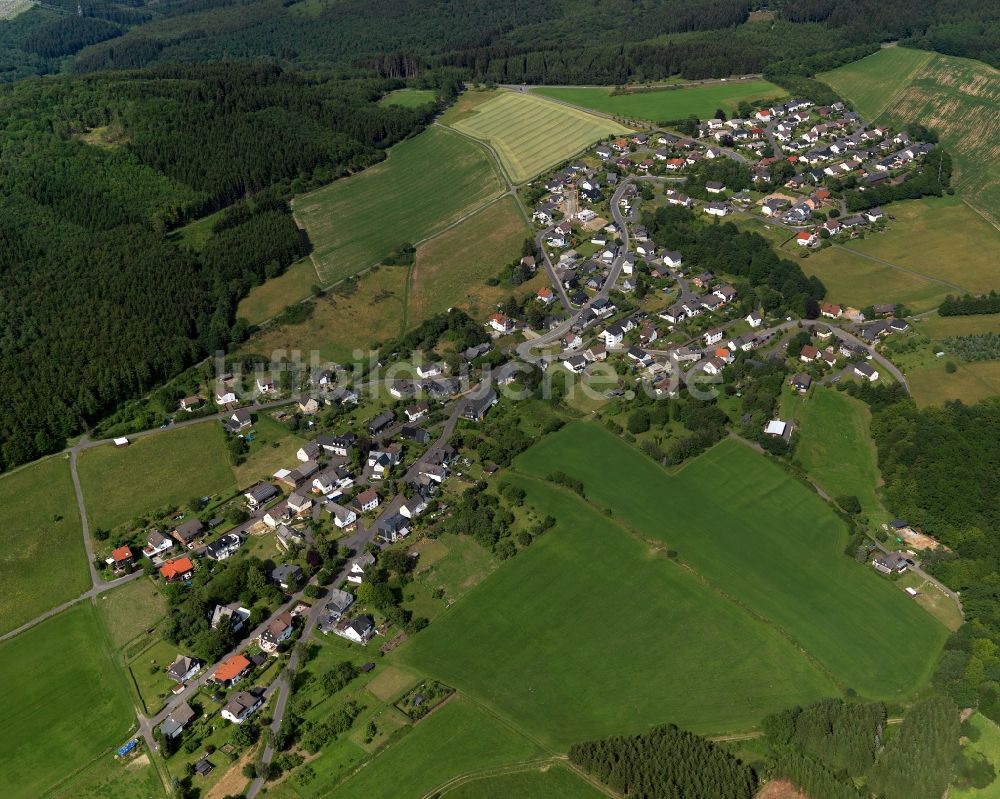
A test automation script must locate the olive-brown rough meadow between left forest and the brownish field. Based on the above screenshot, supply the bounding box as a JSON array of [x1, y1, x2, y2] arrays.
[[244, 266, 408, 364]]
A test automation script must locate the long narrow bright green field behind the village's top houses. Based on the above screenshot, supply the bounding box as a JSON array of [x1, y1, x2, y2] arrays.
[[532, 80, 788, 122]]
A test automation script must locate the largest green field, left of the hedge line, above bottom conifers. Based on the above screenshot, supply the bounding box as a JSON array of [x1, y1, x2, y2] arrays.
[[401, 475, 836, 749]]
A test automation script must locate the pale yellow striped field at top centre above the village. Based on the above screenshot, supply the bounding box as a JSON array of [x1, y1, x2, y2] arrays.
[[451, 92, 628, 183]]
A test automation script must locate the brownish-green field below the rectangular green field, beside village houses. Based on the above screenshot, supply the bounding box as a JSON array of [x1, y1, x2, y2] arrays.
[[407, 197, 547, 326]]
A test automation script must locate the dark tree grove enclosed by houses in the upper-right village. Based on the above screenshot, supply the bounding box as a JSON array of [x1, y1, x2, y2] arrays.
[[643, 206, 826, 319]]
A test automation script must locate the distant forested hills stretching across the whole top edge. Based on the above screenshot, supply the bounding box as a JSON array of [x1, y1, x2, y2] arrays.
[[0, 0, 1000, 84]]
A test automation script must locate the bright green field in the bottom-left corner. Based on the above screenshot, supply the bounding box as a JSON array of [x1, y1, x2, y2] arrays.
[[0, 603, 134, 799]]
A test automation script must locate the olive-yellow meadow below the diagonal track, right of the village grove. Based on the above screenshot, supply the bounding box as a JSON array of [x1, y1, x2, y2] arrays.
[[799, 247, 957, 313]]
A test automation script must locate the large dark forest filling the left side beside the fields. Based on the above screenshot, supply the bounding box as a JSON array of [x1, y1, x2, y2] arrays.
[[0, 65, 442, 467]]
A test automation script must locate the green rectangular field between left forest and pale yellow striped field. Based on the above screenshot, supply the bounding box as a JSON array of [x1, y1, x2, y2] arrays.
[[292, 126, 502, 284]]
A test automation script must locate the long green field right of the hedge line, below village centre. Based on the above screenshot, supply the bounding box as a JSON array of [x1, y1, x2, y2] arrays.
[[512, 422, 947, 699]]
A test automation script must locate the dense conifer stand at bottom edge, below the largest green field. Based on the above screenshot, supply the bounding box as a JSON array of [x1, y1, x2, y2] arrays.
[[569, 724, 757, 799]]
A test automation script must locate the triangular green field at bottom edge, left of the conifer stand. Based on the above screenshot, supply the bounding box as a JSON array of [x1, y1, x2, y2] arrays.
[[309, 697, 542, 799]]
